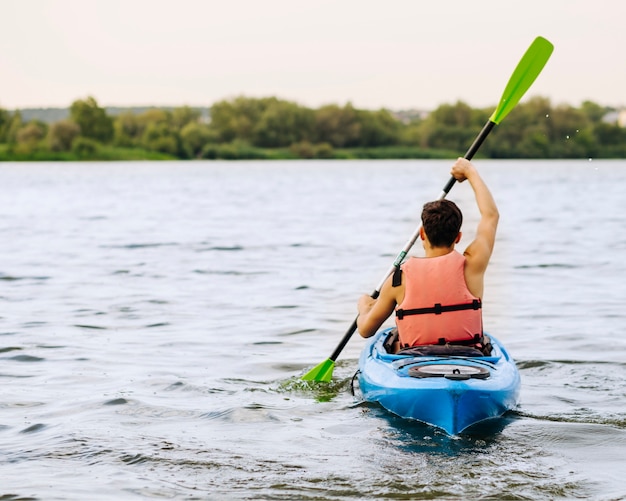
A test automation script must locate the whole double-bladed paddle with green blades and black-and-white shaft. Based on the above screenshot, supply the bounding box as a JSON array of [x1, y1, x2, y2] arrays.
[[302, 37, 554, 382]]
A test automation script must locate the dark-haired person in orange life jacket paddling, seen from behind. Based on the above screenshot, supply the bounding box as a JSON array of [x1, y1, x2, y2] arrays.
[[357, 158, 499, 351]]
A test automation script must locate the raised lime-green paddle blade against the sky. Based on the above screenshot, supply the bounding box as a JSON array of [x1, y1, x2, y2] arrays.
[[489, 37, 554, 124]]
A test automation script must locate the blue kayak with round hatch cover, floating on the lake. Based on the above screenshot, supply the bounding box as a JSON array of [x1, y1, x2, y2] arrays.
[[358, 328, 520, 435]]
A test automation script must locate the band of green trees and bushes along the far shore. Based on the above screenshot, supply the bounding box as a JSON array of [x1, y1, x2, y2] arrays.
[[0, 96, 626, 160]]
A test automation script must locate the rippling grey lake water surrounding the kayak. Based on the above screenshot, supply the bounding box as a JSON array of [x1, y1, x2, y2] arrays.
[[0, 160, 626, 501]]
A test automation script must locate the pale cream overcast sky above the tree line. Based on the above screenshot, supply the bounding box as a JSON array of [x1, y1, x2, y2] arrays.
[[0, 0, 626, 110]]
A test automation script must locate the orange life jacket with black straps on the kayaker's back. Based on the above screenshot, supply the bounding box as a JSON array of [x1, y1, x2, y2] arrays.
[[396, 251, 483, 347]]
